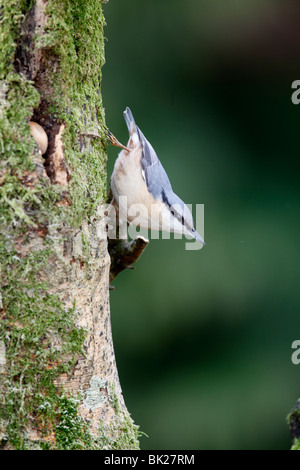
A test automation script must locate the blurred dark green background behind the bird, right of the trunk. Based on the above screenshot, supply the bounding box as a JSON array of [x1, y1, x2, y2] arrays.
[[102, 0, 300, 450]]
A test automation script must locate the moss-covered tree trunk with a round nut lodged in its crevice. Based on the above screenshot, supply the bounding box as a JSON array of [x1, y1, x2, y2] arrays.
[[0, 0, 139, 449]]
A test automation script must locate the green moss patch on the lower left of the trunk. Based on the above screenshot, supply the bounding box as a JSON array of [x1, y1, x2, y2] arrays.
[[0, 236, 85, 449]]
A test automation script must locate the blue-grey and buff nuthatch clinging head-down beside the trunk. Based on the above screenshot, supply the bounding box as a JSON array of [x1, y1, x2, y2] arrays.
[[108, 107, 205, 244]]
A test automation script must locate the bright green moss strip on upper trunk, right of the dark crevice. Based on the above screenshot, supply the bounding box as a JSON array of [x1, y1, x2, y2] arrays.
[[36, 0, 106, 225]]
